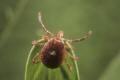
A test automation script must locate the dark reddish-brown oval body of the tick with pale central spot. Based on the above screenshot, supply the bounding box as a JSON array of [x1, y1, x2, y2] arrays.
[[40, 39, 65, 68]]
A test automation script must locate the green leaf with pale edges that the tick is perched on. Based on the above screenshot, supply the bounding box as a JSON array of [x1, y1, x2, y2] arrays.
[[25, 40, 80, 80]]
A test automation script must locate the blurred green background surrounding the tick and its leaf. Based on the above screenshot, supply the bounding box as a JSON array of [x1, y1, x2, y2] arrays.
[[0, 0, 120, 80]]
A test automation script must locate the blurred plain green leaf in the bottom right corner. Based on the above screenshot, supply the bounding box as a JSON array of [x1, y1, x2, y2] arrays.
[[99, 52, 120, 80]]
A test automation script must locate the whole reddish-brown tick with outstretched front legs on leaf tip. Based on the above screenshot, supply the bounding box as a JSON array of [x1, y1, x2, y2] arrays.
[[32, 12, 91, 71]]
